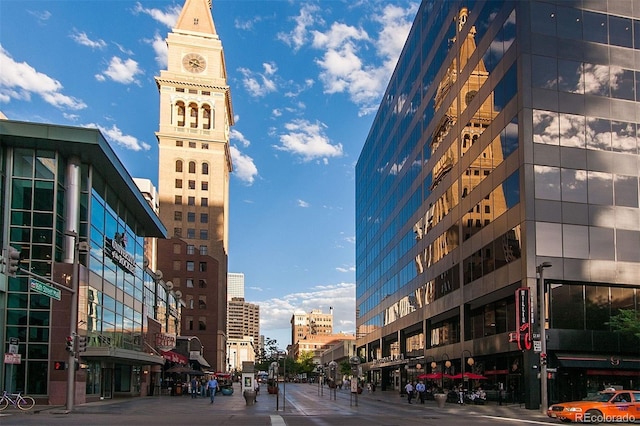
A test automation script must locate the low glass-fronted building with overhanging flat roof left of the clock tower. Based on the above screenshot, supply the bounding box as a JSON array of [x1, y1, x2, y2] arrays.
[[0, 120, 180, 405]]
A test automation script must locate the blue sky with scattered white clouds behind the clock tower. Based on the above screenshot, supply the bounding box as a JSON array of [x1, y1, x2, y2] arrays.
[[0, 0, 419, 348]]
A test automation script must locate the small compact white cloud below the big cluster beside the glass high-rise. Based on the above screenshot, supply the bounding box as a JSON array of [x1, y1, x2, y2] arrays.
[[274, 119, 343, 162]]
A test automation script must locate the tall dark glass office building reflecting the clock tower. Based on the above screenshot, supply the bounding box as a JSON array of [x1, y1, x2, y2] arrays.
[[356, 0, 640, 408]]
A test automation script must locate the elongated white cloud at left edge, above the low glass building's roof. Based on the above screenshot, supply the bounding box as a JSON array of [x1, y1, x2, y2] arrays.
[[0, 45, 87, 110]]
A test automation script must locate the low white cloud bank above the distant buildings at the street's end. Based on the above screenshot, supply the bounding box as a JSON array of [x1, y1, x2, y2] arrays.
[[251, 283, 356, 347]]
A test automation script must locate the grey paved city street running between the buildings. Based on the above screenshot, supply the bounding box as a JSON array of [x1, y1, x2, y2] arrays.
[[0, 383, 557, 426]]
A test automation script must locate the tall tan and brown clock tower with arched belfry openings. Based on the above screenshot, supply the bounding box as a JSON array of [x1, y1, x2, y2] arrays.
[[156, 0, 234, 371]]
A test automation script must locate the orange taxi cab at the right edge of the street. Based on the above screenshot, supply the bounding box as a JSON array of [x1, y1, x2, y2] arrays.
[[547, 390, 640, 423]]
